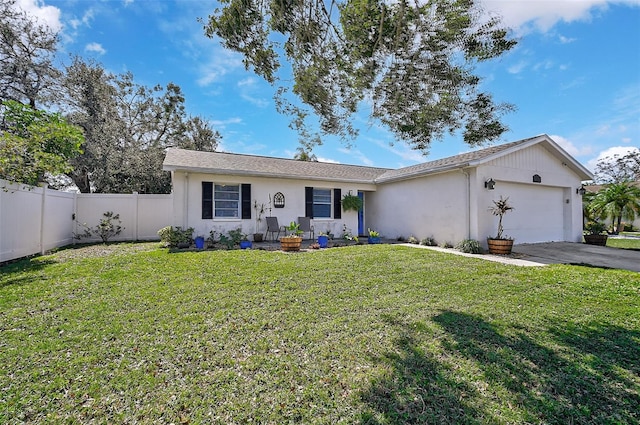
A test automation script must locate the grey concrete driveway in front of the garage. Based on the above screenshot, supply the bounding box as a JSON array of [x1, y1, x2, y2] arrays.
[[513, 242, 640, 272]]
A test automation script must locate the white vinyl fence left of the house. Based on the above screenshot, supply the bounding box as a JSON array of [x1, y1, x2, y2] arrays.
[[0, 180, 173, 262]]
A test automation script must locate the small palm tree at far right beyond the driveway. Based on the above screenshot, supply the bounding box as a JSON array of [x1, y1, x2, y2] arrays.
[[589, 183, 640, 234]]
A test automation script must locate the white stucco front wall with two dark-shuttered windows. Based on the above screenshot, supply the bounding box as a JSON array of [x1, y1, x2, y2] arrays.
[[173, 171, 375, 237]]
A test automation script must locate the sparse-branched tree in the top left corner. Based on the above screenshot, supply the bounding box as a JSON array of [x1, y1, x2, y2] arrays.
[[0, 0, 60, 109]]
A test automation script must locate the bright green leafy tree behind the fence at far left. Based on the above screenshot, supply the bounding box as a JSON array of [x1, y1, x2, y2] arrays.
[[0, 100, 84, 185]]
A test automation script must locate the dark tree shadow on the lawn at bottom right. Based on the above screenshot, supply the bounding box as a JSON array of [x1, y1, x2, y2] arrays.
[[361, 311, 640, 424]]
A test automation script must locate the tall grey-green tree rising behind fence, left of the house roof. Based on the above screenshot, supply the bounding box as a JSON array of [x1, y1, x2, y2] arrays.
[[64, 58, 220, 193]]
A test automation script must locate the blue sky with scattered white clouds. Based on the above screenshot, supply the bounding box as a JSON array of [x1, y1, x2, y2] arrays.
[[18, 0, 640, 169]]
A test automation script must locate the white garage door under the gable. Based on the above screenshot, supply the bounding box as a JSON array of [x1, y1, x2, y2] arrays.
[[496, 182, 564, 243]]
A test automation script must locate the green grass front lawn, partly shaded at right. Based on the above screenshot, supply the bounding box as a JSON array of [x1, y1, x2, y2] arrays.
[[0, 244, 640, 424]]
